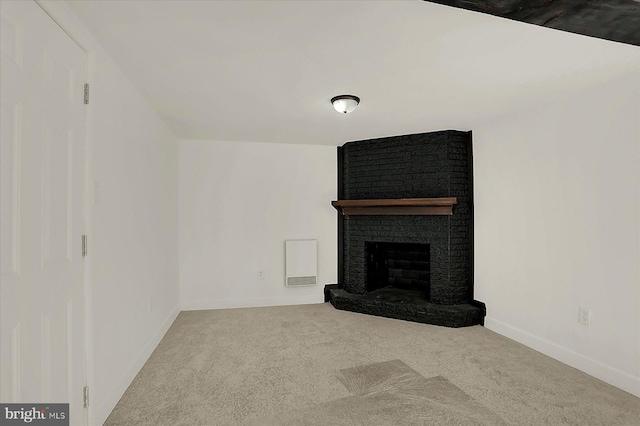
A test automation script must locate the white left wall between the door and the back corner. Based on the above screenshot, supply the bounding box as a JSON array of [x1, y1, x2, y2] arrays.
[[37, 2, 179, 425]]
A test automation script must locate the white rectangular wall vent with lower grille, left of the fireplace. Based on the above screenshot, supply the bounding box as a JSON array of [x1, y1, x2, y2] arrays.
[[284, 240, 318, 287]]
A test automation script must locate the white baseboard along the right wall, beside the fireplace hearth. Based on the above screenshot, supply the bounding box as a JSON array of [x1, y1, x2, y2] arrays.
[[484, 317, 640, 398]]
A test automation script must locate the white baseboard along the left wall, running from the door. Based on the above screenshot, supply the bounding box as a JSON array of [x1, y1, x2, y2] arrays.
[[94, 306, 180, 425]]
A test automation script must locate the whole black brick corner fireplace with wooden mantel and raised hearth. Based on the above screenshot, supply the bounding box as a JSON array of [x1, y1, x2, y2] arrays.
[[325, 130, 485, 327]]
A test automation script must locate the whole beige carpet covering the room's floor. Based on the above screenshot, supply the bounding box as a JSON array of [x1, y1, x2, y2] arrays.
[[106, 304, 640, 426]]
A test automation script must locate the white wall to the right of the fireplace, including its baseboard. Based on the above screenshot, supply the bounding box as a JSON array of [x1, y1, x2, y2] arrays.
[[473, 51, 640, 396]]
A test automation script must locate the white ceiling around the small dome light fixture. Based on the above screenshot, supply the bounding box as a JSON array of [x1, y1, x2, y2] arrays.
[[66, 0, 638, 145]]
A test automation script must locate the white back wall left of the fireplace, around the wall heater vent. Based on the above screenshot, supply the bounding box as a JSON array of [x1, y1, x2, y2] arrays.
[[179, 140, 337, 310]]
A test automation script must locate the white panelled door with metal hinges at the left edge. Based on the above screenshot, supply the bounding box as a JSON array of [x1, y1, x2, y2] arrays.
[[0, 0, 86, 425]]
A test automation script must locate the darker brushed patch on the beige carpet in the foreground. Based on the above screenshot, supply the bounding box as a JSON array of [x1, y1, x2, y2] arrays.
[[242, 360, 506, 426]]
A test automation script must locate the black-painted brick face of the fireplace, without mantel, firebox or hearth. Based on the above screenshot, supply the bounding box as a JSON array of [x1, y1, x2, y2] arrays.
[[342, 131, 471, 305]]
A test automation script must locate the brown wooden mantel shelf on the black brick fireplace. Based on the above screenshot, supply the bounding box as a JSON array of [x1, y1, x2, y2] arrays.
[[331, 197, 458, 216]]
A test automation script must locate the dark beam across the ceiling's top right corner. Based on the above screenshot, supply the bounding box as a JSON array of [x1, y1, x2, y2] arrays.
[[429, 0, 640, 46]]
